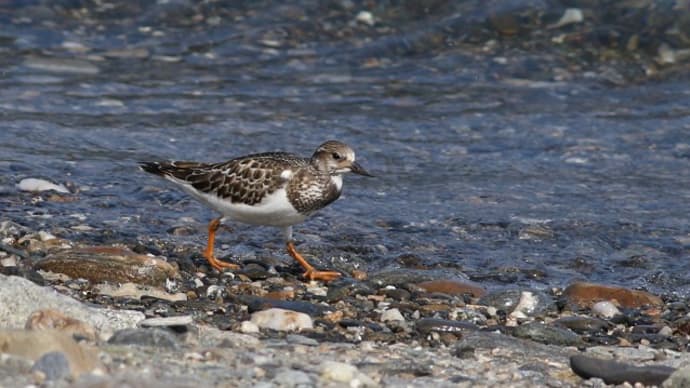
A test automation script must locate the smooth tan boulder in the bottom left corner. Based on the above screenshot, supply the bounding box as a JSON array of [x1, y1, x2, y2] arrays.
[[0, 329, 103, 377]]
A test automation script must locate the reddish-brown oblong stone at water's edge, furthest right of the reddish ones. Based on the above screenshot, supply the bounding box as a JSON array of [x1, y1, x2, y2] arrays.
[[563, 282, 663, 308]]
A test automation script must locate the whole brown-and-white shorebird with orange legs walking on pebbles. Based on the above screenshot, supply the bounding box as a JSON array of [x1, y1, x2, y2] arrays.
[[141, 140, 372, 281]]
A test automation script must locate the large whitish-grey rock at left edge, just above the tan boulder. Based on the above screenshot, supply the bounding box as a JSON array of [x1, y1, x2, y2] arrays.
[[0, 275, 144, 339]]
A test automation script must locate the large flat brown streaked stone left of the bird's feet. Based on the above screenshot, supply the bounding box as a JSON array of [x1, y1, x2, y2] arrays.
[[34, 246, 180, 287]]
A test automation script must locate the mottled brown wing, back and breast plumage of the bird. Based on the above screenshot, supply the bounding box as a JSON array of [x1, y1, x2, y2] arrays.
[[142, 152, 340, 214]]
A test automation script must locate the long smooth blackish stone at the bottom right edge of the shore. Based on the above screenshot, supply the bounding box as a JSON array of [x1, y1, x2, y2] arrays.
[[570, 354, 675, 386]]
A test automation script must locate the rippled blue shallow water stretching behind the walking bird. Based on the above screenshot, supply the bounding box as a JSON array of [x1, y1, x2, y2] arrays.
[[0, 1, 690, 296]]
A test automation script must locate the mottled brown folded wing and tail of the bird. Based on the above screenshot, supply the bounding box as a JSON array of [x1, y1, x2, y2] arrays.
[[141, 152, 308, 205]]
